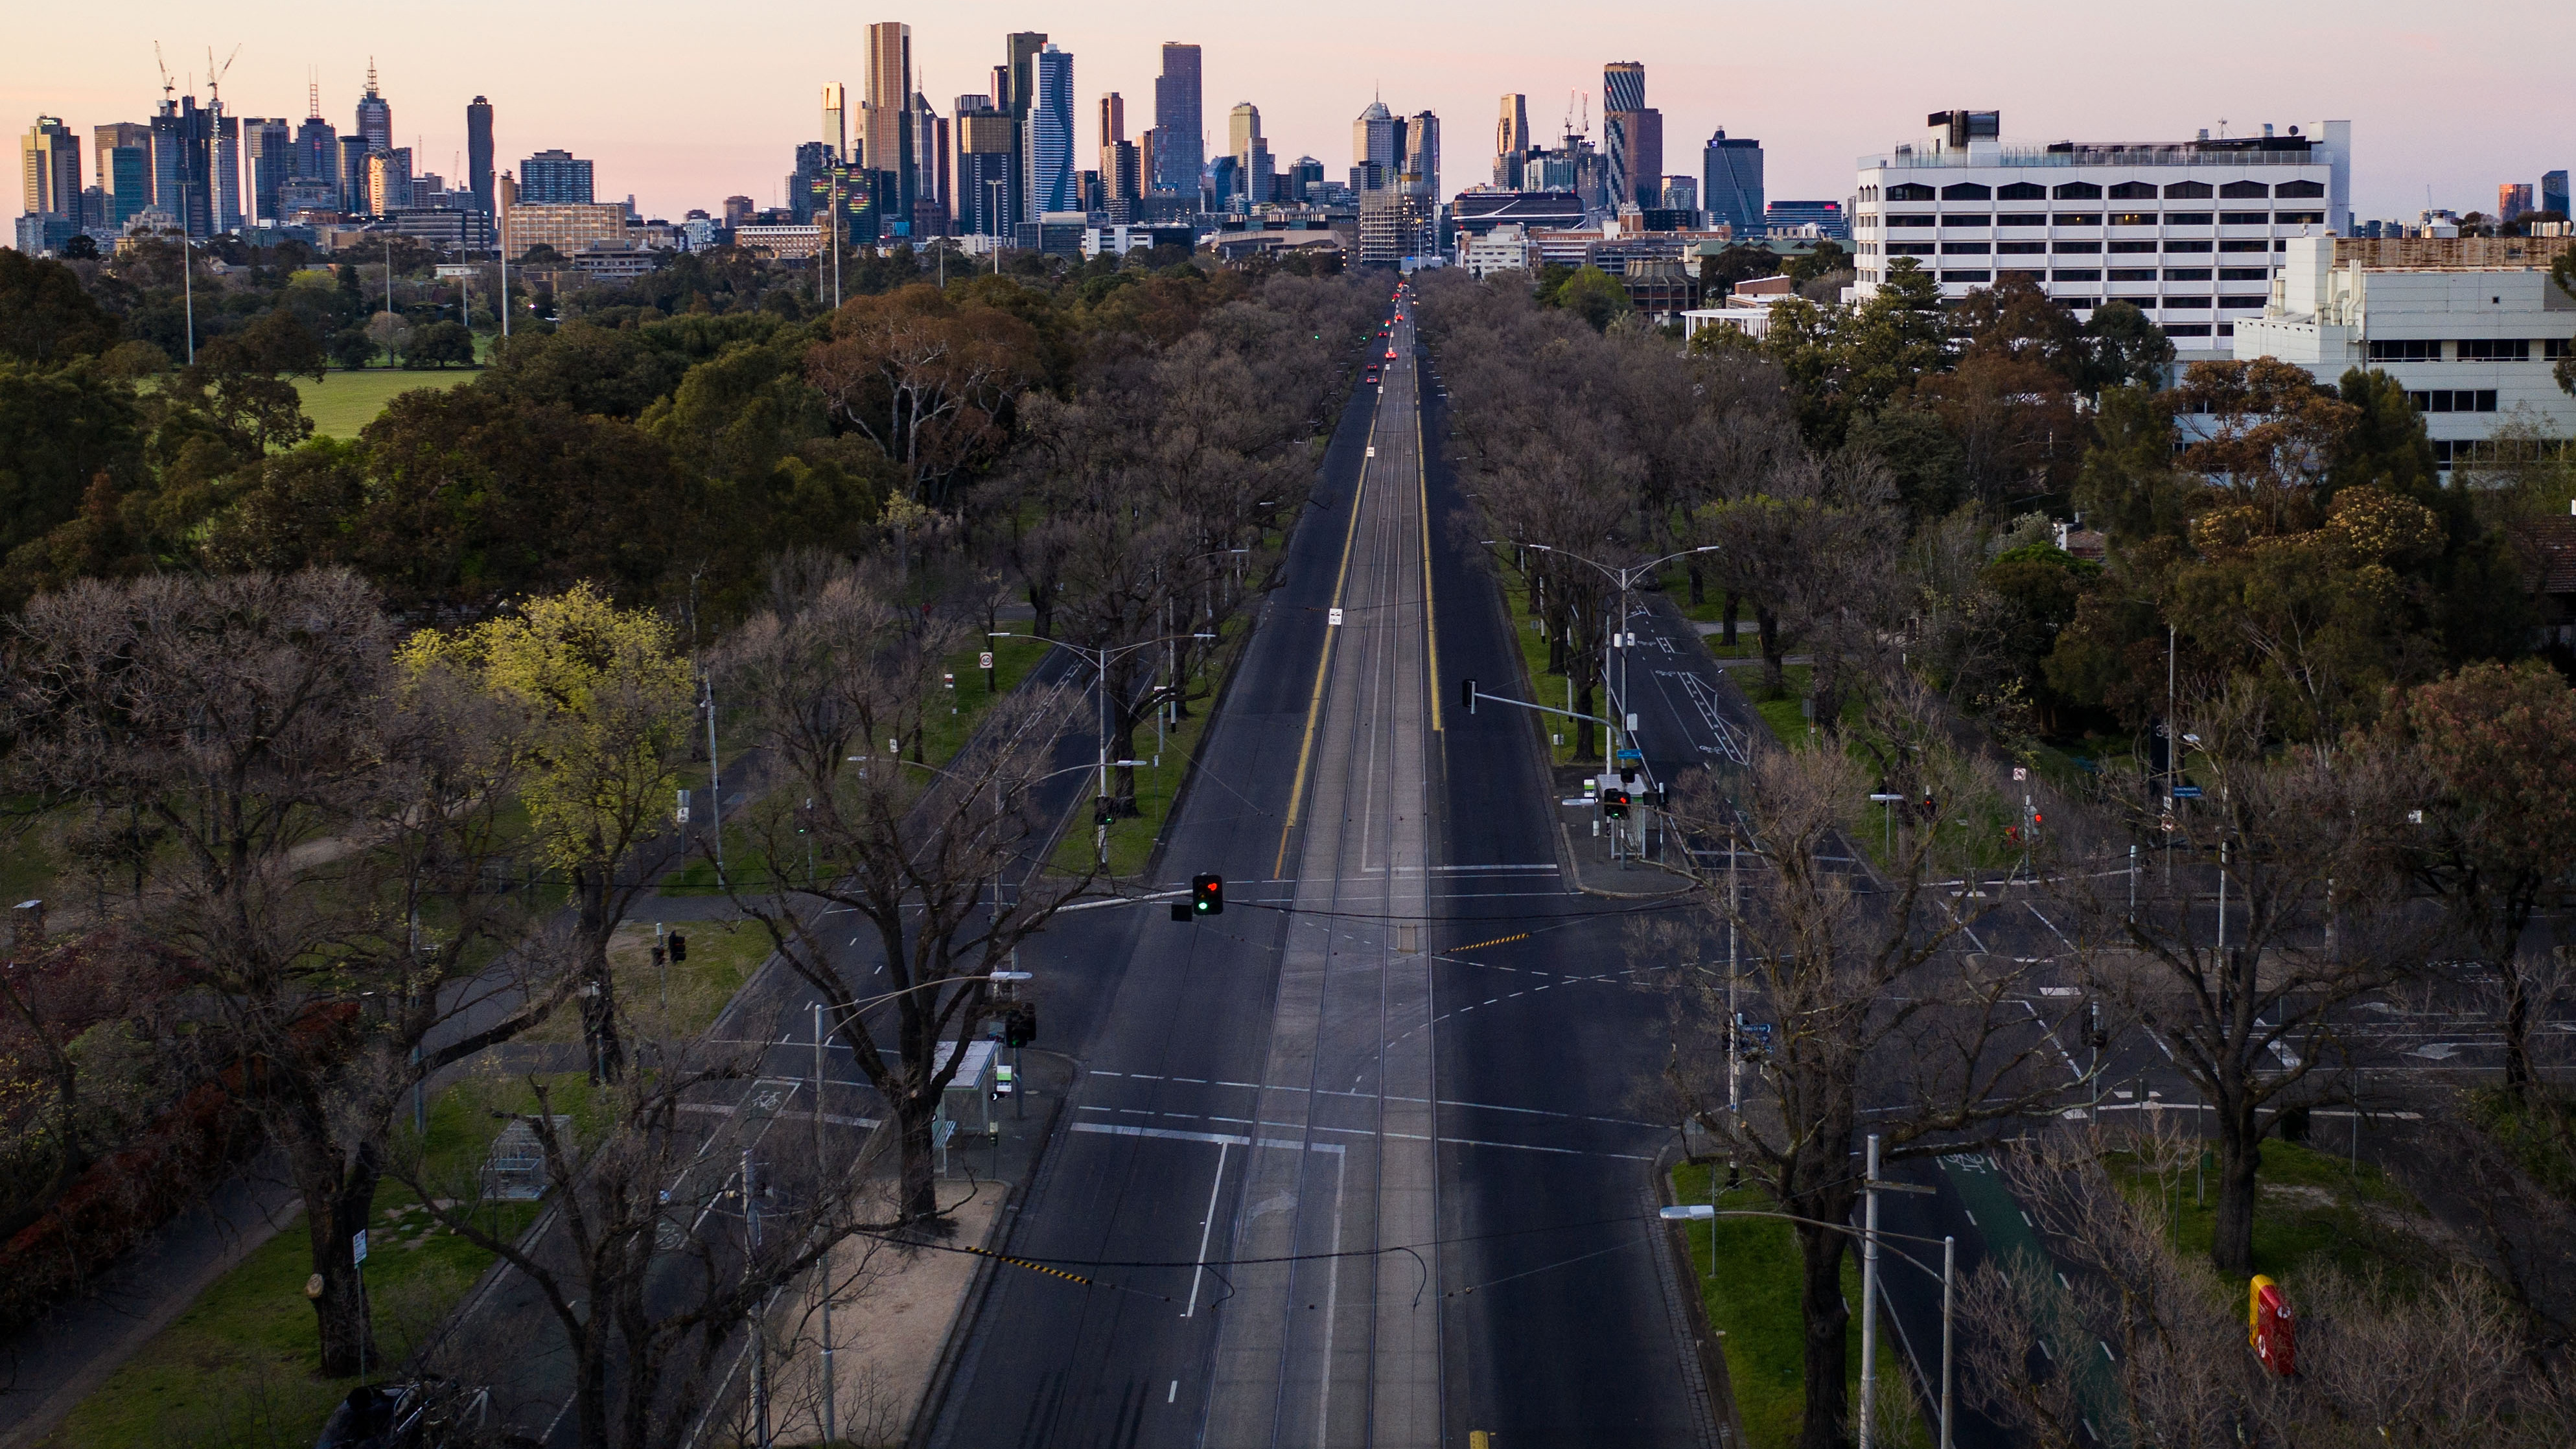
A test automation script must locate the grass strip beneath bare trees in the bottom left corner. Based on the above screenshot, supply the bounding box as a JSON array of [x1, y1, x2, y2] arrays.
[[44, 1081, 541, 1449]]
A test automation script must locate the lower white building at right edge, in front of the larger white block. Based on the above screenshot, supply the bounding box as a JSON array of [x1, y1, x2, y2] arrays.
[[2231, 237, 2576, 469]]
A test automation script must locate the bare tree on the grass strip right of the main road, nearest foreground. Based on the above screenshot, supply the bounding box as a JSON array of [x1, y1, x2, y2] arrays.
[[1669, 684, 2063, 1449]]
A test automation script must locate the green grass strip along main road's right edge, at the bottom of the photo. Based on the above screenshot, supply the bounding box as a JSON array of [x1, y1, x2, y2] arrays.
[[1672, 1163, 1929, 1449]]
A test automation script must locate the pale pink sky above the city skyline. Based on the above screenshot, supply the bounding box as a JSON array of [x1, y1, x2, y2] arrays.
[[15, 0, 2576, 219]]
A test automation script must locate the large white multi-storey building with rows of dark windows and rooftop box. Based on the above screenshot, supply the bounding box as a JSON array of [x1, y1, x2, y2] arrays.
[[1852, 111, 2352, 363]]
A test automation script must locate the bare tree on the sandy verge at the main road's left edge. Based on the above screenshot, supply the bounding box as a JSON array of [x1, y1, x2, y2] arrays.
[[724, 569, 1089, 1220]]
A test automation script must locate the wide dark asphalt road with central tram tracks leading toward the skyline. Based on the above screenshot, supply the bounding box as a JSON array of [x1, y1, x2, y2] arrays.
[[935, 277, 1713, 1446]]
